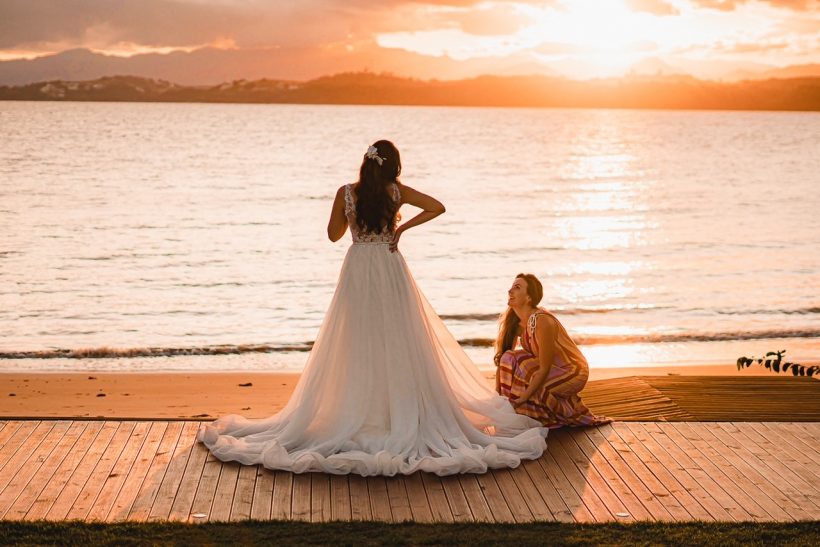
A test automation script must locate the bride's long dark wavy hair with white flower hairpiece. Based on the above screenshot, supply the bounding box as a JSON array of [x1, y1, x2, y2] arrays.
[[356, 140, 401, 233]]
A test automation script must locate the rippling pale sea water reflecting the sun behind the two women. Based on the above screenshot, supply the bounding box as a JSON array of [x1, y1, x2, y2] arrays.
[[0, 102, 820, 370]]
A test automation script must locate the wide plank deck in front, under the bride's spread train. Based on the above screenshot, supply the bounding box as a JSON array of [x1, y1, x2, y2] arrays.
[[0, 420, 820, 522]]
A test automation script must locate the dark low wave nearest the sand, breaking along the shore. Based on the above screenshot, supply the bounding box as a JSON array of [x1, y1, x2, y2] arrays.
[[0, 329, 820, 359]]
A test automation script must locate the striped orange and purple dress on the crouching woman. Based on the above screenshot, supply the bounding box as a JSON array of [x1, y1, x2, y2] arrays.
[[497, 308, 612, 428]]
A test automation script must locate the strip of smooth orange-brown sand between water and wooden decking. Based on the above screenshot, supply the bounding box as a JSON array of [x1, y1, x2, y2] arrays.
[[0, 364, 773, 419]]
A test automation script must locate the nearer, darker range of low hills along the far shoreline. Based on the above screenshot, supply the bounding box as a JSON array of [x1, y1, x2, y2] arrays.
[[0, 72, 820, 111]]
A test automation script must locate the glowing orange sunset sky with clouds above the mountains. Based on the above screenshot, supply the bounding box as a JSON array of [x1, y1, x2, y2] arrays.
[[0, 0, 820, 78]]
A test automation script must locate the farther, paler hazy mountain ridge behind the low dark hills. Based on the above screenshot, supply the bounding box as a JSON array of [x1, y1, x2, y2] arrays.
[[0, 47, 820, 85]]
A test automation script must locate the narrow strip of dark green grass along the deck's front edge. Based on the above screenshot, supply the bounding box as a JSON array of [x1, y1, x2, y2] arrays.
[[0, 521, 820, 547]]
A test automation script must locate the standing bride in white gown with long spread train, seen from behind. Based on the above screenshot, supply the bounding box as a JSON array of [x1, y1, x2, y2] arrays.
[[198, 140, 548, 475]]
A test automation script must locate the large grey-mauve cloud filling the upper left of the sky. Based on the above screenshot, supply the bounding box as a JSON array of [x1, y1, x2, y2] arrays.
[[0, 0, 475, 49]]
